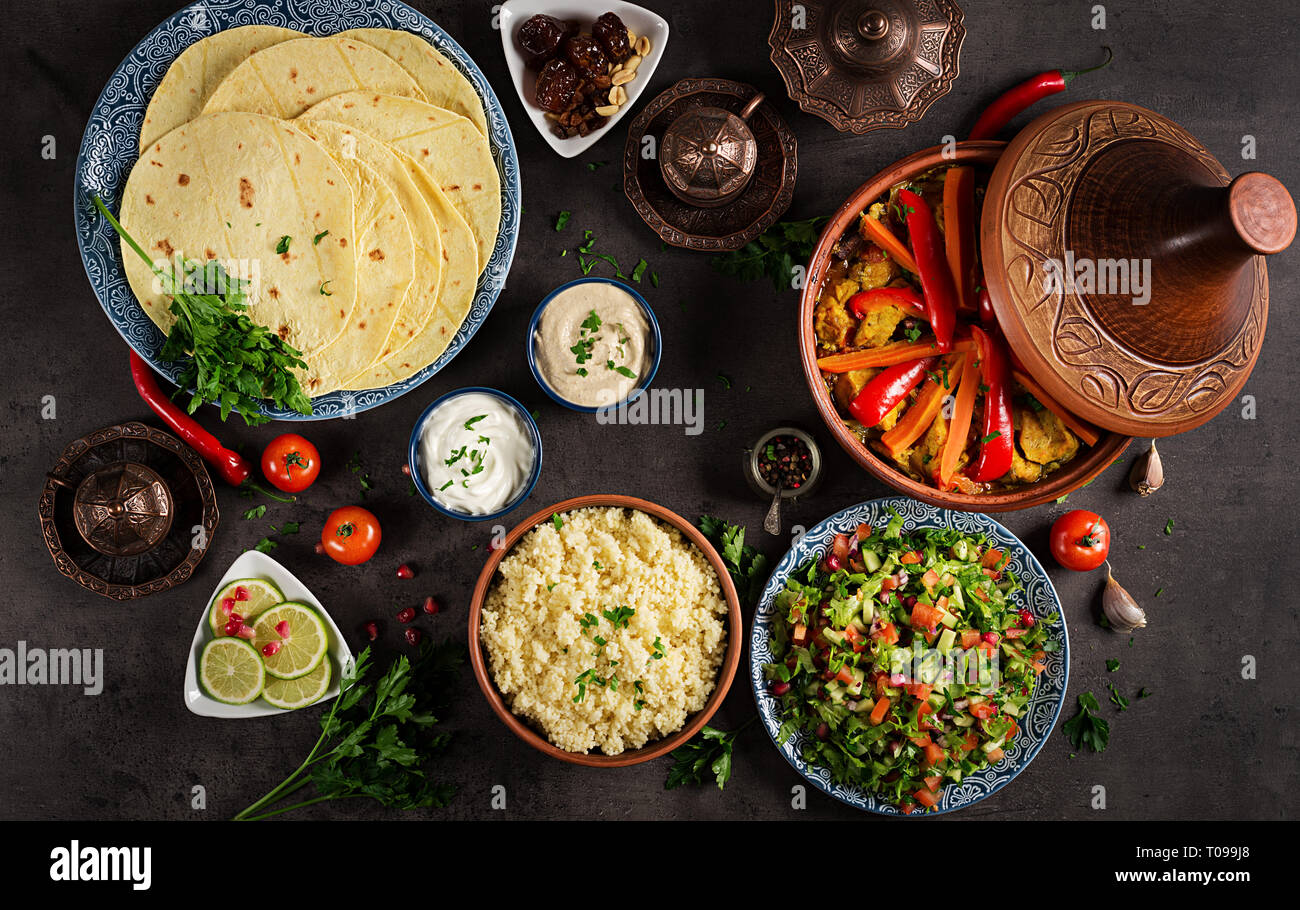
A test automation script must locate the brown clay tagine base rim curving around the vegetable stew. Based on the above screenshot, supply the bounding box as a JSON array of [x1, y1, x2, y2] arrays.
[[800, 142, 1132, 512]]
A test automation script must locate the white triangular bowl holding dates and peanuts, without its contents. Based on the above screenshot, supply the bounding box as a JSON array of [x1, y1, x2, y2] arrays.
[[501, 0, 668, 159]]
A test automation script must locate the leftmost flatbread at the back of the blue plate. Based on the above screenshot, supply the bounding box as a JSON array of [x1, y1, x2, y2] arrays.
[[140, 25, 306, 153]]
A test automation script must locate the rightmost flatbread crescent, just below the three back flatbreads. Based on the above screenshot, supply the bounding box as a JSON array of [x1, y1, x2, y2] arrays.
[[299, 91, 501, 274]]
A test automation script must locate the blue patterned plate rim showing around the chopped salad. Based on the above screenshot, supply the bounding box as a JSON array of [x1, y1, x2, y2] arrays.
[[749, 498, 1070, 815]]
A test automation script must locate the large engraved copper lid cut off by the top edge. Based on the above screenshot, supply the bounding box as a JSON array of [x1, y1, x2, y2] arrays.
[[767, 0, 966, 134]]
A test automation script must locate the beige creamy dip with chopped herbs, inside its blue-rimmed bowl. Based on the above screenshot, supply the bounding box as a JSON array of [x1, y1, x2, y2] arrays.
[[533, 281, 650, 408]]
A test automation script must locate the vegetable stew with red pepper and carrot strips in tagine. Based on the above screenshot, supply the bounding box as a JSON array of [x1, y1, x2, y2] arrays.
[[813, 166, 1101, 494]]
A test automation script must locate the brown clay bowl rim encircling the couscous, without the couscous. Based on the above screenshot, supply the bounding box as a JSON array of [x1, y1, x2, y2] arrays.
[[469, 494, 745, 768]]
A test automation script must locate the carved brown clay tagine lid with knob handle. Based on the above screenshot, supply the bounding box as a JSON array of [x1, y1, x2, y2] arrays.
[[980, 100, 1296, 437]]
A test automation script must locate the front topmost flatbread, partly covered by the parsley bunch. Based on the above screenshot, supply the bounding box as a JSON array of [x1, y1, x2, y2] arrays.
[[120, 113, 358, 358]]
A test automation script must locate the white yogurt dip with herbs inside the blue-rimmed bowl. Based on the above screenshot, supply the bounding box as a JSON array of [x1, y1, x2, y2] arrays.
[[420, 391, 536, 515]]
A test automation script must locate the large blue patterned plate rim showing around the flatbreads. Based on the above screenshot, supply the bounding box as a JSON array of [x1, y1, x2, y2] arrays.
[[73, 0, 523, 420]]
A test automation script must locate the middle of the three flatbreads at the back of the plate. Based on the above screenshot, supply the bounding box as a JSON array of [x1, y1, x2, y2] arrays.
[[203, 38, 424, 120]]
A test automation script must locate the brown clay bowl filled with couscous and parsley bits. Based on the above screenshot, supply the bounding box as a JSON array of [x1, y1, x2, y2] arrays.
[[469, 495, 744, 768]]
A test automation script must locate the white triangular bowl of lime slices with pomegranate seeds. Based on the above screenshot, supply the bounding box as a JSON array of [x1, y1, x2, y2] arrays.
[[185, 550, 352, 719]]
